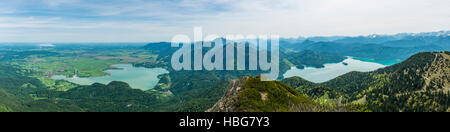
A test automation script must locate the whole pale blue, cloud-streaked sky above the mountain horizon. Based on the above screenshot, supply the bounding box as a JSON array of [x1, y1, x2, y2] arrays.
[[0, 0, 450, 42]]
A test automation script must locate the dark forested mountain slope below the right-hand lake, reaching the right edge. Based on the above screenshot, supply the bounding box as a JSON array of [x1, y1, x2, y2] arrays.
[[282, 52, 450, 111]]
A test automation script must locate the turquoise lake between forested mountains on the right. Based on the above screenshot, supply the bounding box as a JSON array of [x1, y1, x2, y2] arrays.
[[283, 57, 400, 83]]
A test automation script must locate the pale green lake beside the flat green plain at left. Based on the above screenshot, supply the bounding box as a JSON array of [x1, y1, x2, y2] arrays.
[[52, 64, 169, 90]]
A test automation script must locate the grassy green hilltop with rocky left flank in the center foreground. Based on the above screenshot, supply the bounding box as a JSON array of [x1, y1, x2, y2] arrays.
[[208, 76, 360, 112]]
